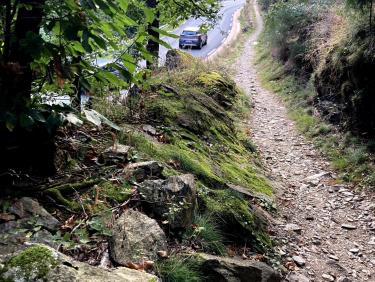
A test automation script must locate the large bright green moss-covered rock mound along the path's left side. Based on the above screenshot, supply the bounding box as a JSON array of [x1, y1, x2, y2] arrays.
[[120, 57, 273, 250]]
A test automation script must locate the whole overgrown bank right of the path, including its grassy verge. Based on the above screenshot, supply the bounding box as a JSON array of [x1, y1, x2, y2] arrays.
[[257, 1, 375, 187]]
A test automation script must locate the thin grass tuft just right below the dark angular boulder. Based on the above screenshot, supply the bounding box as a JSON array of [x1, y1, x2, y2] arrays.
[[184, 214, 225, 256]]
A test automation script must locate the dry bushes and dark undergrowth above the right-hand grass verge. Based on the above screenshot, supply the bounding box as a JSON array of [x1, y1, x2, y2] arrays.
[[265, 1, 375, 134]]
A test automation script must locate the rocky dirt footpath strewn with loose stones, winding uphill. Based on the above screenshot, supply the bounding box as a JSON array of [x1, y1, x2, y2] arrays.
[[236, 1, 375, 282]]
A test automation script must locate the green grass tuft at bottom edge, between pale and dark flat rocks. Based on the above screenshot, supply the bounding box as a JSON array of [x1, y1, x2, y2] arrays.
[[155, 256, 205, 282]]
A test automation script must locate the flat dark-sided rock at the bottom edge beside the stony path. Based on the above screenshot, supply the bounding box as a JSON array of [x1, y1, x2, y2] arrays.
[[199, 254, 281, 282]]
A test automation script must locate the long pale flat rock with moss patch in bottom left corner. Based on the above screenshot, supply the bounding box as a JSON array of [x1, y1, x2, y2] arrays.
[[0, 244, 158, 282]]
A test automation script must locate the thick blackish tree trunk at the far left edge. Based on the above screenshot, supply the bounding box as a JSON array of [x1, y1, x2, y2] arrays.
[[0, 0, 45, 112]]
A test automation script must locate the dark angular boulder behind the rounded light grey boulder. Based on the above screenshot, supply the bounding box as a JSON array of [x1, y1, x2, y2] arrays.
[[138, 174, 197, 229]]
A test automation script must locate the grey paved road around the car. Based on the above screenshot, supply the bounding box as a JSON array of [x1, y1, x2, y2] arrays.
[[160, 0, 246, 62]]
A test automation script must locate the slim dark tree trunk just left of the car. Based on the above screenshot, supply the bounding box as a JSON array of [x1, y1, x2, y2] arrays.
[[146, 0, 160, 69]]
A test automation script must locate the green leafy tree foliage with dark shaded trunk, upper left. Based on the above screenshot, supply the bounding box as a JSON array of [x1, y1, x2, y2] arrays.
[[0, 0, 219, 173]]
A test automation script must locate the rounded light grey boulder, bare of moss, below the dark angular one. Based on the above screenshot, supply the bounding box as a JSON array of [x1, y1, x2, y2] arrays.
[[109, 209, 167, 266]]
